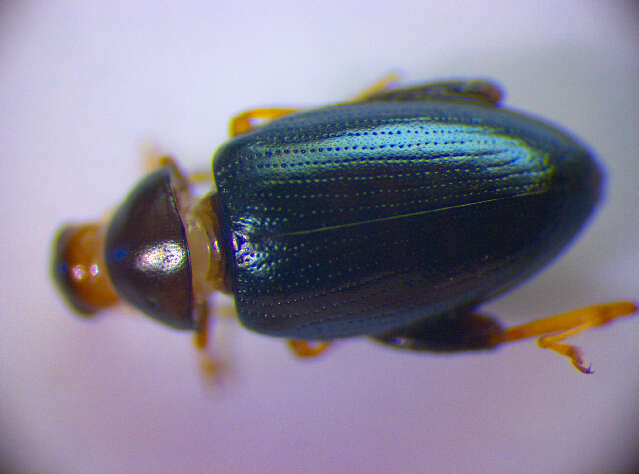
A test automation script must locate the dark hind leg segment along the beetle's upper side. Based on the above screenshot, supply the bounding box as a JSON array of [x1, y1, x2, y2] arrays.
[[354, 80, 502, 105]]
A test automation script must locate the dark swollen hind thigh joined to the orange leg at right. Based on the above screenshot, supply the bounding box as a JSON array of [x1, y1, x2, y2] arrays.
[[372, 310, 501, 352]]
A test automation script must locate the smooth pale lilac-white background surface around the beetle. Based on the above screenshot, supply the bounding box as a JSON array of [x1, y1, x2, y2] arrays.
[[0, 1, 639, 472]]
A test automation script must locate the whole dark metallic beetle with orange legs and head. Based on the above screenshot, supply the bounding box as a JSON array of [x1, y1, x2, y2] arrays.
[[53, 78, 637, 373]]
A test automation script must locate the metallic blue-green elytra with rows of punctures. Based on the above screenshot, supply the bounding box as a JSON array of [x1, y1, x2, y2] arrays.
[[213, 89, 601, 340]]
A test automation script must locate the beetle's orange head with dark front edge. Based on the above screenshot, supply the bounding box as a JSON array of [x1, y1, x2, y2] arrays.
[[52, 223, 119, 317]]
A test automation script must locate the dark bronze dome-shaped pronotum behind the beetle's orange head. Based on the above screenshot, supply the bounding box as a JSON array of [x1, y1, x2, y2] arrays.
[[105, 167, 196, 329]]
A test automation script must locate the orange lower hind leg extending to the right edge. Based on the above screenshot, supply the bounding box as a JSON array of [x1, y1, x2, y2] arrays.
[[494, 301, 639, 374]]
